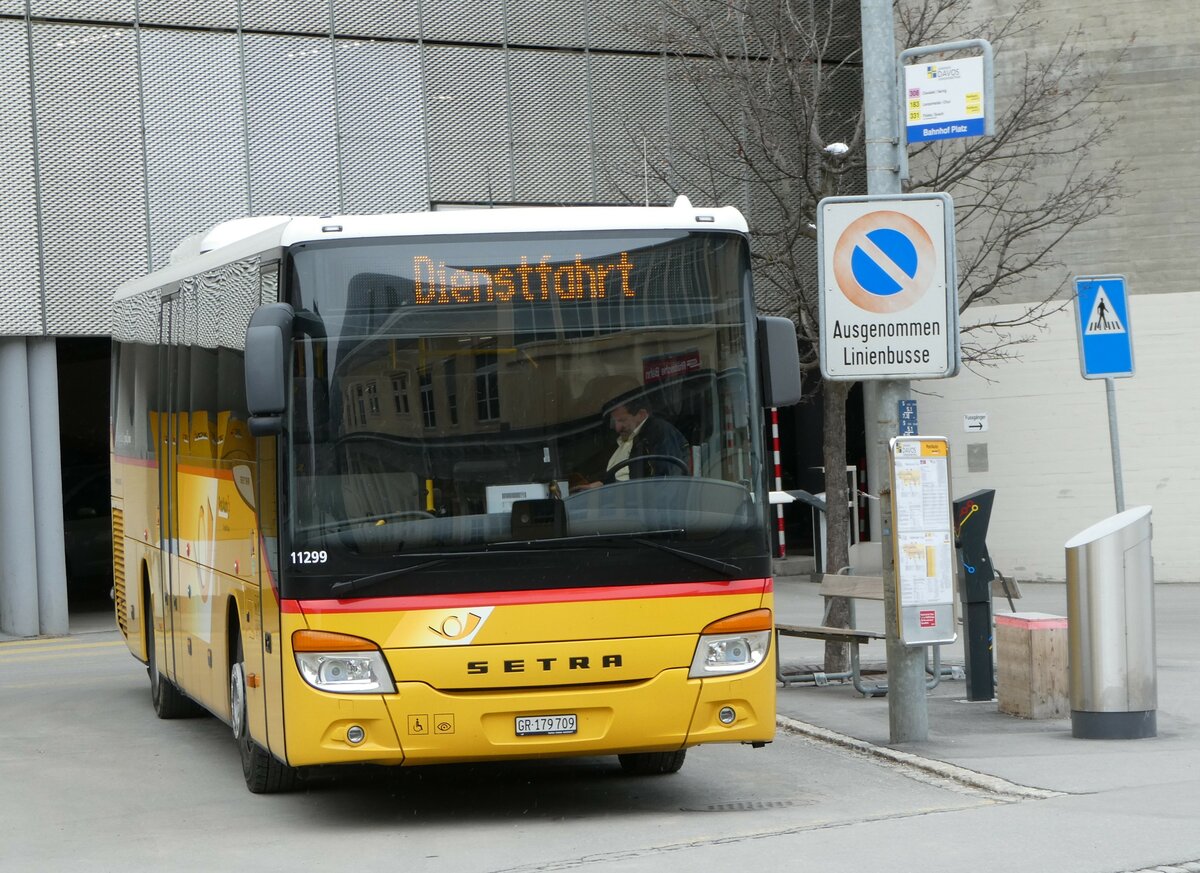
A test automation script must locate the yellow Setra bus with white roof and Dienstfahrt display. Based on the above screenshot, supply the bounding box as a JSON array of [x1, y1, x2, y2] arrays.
[[110, 203, 799, 793]]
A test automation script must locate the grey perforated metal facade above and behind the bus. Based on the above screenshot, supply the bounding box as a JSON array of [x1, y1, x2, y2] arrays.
[[0, 0, 857, 336]]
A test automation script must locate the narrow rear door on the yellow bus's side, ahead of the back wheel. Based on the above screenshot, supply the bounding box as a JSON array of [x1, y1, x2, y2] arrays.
[[155, 291, 187, 686]]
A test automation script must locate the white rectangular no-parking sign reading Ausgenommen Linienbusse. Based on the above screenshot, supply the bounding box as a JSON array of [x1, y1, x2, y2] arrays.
[[817, 194, 959, 380]]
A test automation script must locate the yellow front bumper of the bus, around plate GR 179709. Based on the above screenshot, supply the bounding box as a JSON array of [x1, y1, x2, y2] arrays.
[[280, 657, 775, 766]]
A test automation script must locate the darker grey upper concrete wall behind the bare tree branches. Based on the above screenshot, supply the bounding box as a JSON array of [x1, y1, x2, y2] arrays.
[[964, 0, 1200, 300]]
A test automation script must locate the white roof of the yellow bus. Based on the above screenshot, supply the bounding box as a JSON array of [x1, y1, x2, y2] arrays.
[[113, 197, 748, 300]]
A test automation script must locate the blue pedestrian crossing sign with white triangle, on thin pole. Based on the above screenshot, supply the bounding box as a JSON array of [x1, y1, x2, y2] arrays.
[[1075, 276, 1133, 379]]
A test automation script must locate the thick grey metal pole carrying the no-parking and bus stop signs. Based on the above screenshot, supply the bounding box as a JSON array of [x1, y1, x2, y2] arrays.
[[859, 0, 929, 742]]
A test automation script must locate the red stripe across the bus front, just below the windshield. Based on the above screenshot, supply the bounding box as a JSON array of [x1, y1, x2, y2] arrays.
[[280, 578, 774, 614]]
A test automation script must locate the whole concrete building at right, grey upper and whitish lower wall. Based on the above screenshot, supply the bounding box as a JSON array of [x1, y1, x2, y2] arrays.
[[913, 0, 1200, 582]]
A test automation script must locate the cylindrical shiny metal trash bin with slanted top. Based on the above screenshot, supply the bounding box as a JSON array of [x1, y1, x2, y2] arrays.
[[1066, 506, 1158, 740]]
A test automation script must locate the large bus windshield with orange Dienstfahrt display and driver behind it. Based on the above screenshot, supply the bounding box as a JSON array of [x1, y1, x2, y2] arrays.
[[281, 231, 769, 597]]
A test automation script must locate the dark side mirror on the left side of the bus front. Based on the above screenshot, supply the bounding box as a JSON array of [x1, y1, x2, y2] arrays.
[[246, 303, 295, 437]]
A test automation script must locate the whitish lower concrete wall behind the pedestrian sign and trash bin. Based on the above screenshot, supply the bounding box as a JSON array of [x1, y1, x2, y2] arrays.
[[913, 291, 1200, 582]]
